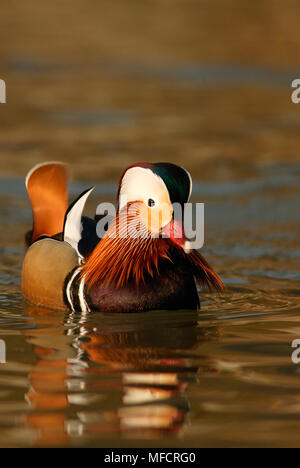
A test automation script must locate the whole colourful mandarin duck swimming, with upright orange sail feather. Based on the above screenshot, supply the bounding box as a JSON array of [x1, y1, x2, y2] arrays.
[[22, 162, 223, 312]]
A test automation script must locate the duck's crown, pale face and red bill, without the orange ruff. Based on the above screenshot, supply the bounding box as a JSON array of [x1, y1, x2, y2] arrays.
[[118, 163, 192, 250]]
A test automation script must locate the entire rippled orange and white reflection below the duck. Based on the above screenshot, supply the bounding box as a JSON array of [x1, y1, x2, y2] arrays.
[[26, 309, 218, 445]]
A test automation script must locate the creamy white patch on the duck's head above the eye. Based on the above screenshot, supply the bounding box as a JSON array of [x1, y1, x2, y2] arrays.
[[119, 167, 171, 210]]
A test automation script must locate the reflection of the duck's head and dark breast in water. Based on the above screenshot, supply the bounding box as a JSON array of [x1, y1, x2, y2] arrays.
[[82, 314, 197, 437]]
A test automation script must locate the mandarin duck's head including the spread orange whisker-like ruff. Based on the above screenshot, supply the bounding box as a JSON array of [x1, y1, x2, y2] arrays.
[[82, 163, 222, 289]]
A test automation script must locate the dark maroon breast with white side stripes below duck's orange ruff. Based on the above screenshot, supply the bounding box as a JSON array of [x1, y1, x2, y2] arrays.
[[65, 245, 200, 312]]
